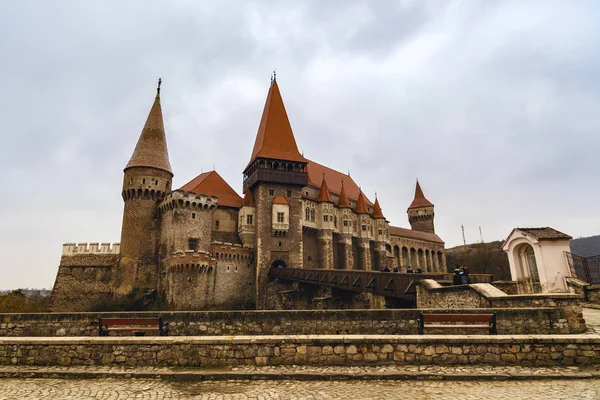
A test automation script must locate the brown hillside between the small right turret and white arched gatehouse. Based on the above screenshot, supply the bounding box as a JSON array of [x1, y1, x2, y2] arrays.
[[446, 241, 510, 280]]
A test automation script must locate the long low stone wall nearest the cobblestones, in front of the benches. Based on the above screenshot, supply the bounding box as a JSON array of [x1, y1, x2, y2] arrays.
[[0, 335, 600, 367]]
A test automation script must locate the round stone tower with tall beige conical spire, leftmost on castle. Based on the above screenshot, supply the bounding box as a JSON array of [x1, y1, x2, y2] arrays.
[[117, 79, 173, 294]]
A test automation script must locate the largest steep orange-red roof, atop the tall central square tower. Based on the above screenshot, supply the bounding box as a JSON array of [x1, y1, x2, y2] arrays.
[[250, 81, 307, 163]]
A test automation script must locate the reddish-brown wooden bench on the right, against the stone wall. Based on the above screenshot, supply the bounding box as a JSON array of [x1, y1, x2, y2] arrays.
[[418, 313, 498, 335]]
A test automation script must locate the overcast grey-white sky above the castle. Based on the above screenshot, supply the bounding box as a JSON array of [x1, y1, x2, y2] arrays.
[[0, 0, 600, 288]]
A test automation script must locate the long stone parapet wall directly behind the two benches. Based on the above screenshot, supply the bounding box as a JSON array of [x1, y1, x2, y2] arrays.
[[0, 306, 585, 336]]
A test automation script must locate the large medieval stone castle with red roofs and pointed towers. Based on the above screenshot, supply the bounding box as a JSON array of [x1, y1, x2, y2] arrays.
[[52, 79, 446, 311]]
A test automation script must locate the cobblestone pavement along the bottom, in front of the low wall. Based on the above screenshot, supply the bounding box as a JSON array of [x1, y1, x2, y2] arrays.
[[0, 379, 600, 400]]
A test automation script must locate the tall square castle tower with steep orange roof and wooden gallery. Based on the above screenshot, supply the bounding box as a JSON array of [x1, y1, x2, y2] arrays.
[[243, 79, 308, 308]]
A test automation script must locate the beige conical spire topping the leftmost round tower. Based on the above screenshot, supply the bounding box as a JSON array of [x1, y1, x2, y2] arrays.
[[125, 78, 173, 173]]
